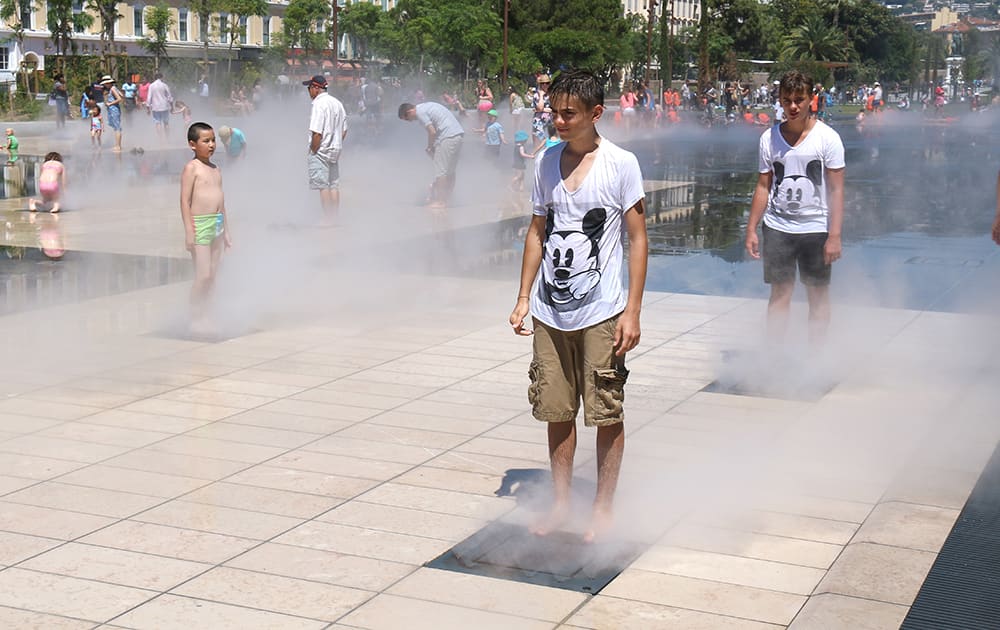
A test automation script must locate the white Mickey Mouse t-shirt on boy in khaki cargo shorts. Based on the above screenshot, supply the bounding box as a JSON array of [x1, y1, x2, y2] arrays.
[[531, 138, 645, 331]]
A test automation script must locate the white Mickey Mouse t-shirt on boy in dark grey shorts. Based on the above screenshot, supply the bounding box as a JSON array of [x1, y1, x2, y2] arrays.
[[758, 120, 844, 234]]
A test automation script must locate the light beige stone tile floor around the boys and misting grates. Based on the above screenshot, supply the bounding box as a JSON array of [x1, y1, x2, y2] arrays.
[[0, 163, 1000, 630]]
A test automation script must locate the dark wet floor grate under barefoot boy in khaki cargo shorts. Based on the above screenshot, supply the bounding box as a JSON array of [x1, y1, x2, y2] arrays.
[[425, 521, 646, 595]]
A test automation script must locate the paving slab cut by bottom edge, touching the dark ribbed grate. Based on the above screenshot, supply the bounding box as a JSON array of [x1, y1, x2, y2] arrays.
[[788, 594, 908, 630]]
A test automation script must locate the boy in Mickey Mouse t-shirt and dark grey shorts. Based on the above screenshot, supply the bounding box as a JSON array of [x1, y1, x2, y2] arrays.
[[746, 72, 844, 344]]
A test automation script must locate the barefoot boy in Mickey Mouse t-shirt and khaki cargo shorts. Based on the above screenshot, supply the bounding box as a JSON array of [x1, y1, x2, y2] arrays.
[[510, 72, 648, 542]]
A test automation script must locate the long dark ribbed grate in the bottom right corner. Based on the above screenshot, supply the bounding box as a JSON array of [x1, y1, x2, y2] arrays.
[[900, 446, 1000, 630]]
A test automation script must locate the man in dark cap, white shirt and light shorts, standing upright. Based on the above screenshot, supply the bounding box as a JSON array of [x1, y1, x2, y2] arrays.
[[302, 74, 347, 224]]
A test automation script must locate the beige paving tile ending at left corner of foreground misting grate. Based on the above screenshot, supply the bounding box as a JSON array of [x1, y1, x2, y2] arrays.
[[226, 543, 416, 591]]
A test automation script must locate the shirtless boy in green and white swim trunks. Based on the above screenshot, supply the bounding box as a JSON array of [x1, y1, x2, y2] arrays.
[[181, 122, 232, 332]]
